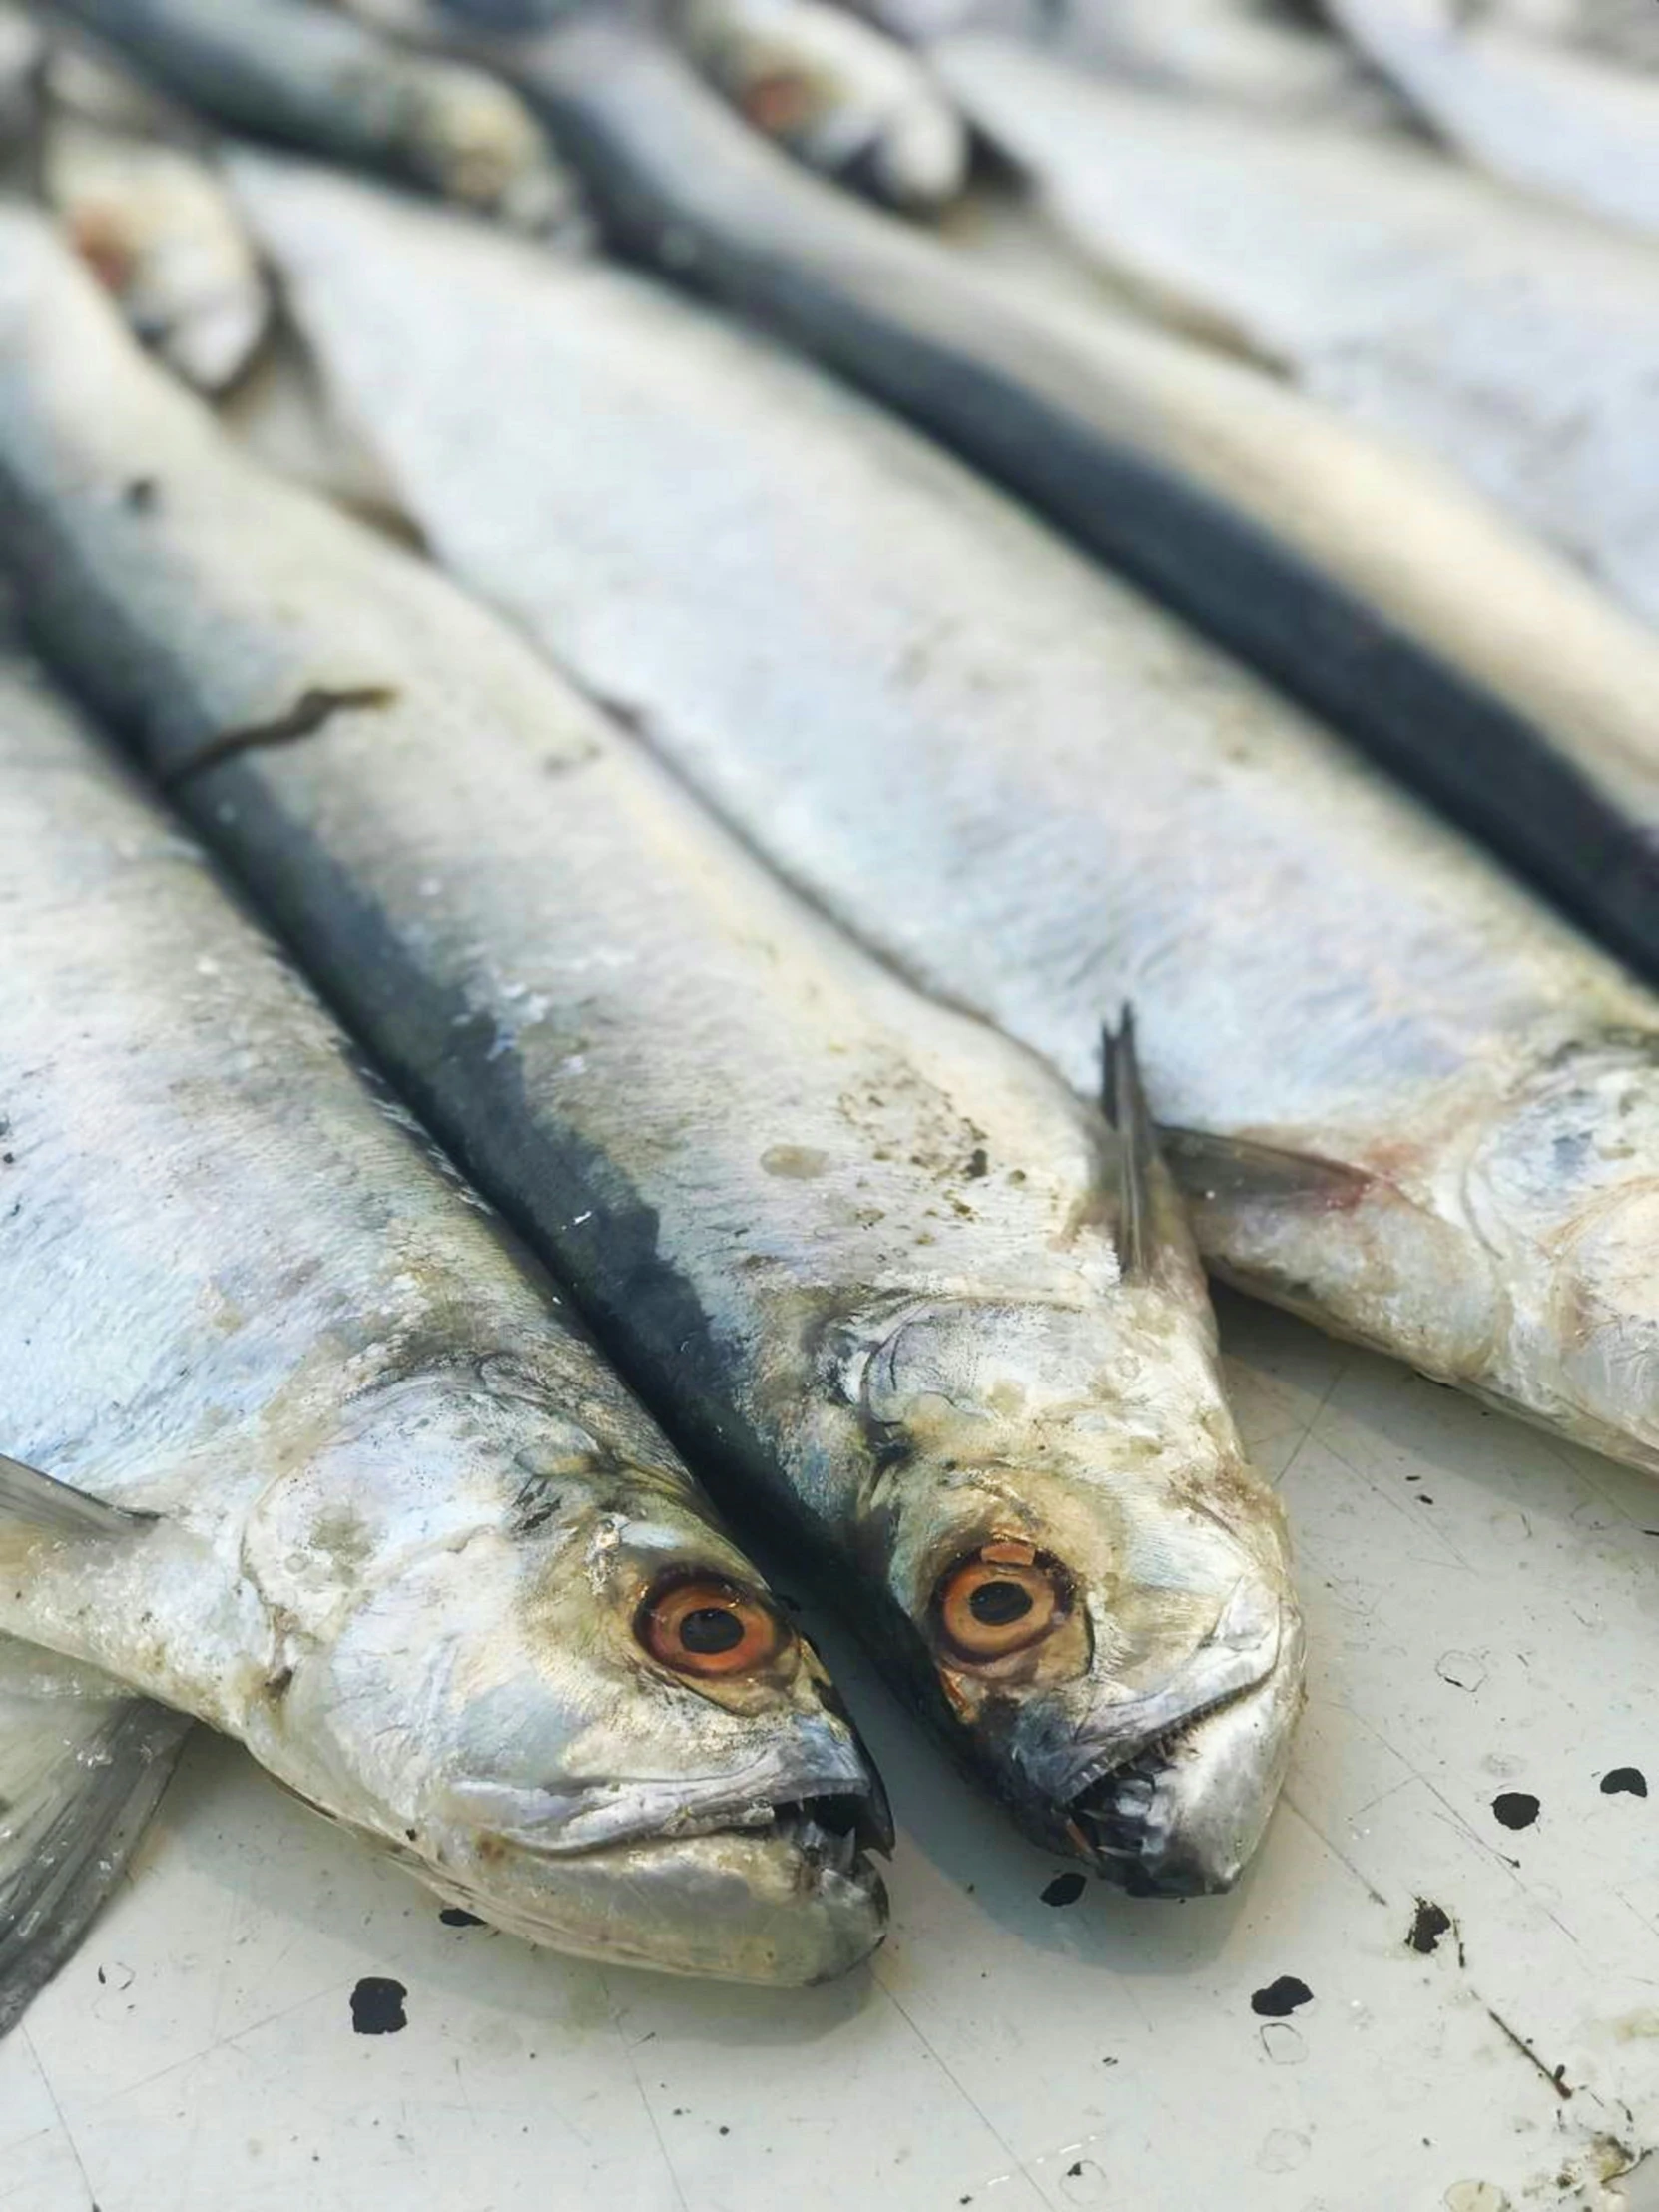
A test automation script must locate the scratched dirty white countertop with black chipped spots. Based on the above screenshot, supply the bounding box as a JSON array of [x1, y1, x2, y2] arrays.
[[0, 1301, 1659, 2212]]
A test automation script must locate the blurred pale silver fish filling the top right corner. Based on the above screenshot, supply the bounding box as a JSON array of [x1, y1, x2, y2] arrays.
[[1328, 0, 1659, 237]]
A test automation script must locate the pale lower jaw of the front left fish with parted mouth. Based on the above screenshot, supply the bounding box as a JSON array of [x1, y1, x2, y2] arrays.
[[422, 1796, 887, 1988]]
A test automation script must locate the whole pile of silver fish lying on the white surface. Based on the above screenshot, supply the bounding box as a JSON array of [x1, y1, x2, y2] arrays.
[[0, 0, 1659, 2028]]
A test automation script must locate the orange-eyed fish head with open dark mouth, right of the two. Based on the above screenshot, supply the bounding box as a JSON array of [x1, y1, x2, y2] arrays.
[[860, 1290, 1303, 1896]]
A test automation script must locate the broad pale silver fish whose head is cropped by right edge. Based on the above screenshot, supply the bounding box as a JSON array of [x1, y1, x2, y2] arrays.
[[235, 157, 1659, 1473]]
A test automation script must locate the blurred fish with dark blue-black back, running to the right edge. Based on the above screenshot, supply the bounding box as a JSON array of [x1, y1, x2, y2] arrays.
[[451, 22, 1659, 977]]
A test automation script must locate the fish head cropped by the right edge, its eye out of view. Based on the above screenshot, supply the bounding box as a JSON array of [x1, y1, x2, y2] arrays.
[[1462, 1028, 1659, 1473]]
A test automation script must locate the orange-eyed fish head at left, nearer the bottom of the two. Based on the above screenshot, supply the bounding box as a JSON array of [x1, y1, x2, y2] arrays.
[[246, 1391, 891, 1984]]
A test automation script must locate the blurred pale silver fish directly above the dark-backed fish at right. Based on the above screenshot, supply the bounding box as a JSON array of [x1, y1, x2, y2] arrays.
[[933, 40, 1659, 619]]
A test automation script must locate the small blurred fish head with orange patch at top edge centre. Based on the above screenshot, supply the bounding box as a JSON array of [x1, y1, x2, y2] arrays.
[[673, 0, 969, 213]]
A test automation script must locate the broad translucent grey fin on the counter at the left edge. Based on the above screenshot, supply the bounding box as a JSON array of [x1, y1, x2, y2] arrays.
[[0, 1637, 193, 2035]]
